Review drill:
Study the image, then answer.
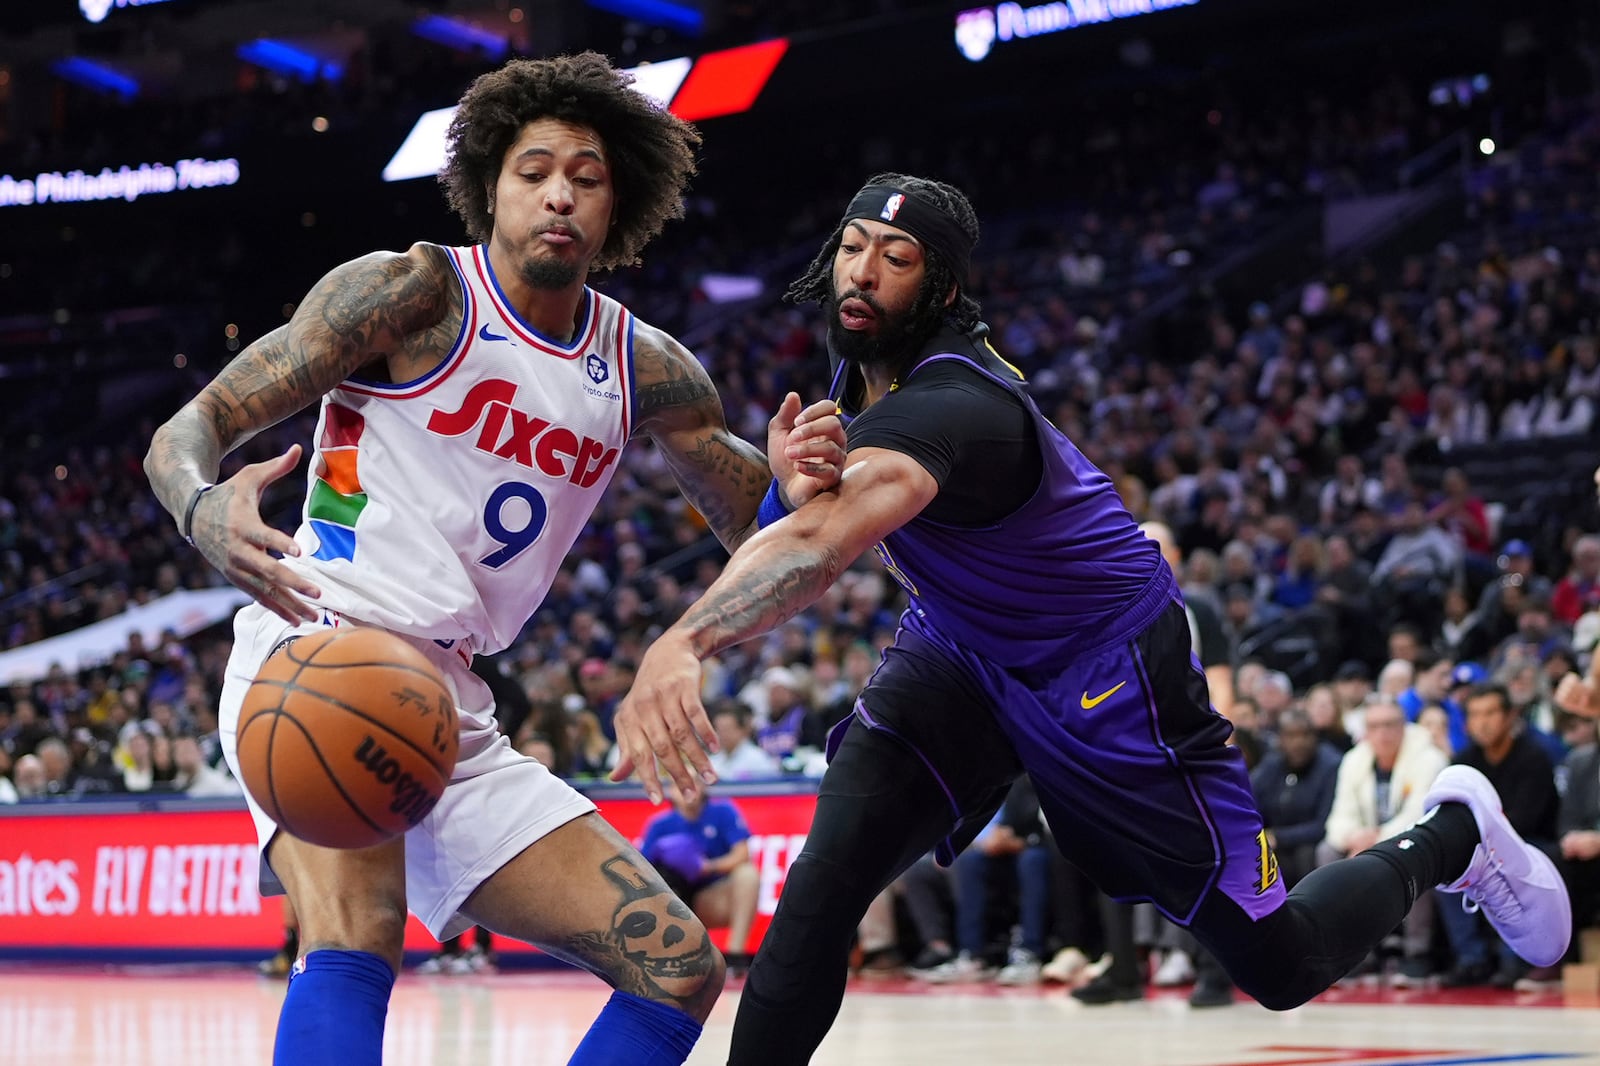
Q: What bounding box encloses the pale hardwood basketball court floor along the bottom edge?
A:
[0,964,1600,1066]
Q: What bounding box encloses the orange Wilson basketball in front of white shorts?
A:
[238,629,459,848]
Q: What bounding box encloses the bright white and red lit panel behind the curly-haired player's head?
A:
[384,37,789,181]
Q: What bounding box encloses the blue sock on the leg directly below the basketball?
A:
[272,949,395,1066]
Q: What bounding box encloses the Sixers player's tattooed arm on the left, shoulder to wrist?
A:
[144,245,461,517]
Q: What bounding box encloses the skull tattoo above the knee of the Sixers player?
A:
[552,853,720,1013]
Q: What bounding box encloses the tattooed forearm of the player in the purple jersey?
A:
[674,539,843,659]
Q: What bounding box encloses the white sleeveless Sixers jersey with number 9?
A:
[285,246,634,653]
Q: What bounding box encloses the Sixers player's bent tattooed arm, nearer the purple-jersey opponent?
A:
[634,328,773,551]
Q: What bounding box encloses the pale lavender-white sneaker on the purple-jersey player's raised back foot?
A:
[1427,765,1573,967]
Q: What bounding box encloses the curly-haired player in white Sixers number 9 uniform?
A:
[146,53,843,1066]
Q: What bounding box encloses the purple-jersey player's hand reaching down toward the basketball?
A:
[611,632,717,804]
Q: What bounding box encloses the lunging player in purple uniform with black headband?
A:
[616,174,1570,1066]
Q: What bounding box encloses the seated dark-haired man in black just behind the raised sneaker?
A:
[1440,685,1560,988]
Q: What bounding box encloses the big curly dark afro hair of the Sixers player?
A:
[438,51,701,271]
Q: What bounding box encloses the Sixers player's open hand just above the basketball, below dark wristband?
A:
[190,445,322,623]
